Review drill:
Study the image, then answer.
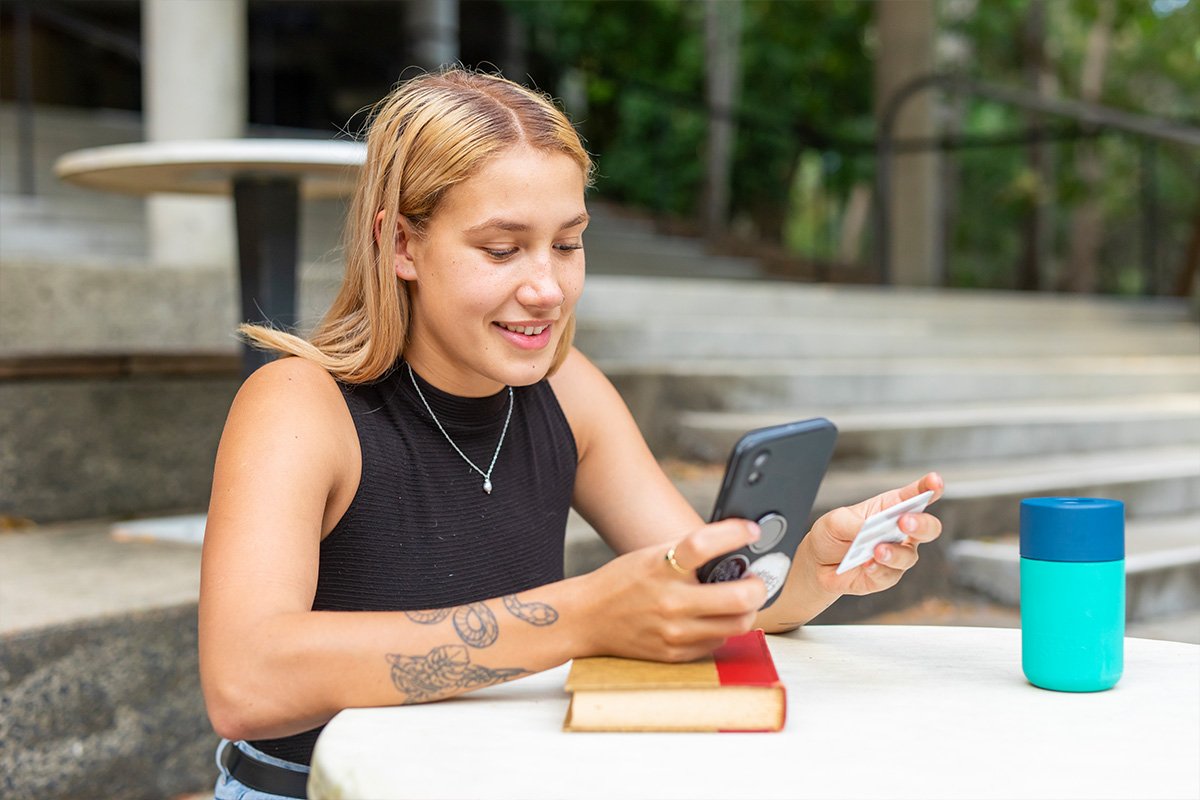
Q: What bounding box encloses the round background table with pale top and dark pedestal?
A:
[54,139,366,374]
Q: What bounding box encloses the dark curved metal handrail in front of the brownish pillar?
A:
[875,73,1200,284]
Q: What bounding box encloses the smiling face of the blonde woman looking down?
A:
[396,146,588,397]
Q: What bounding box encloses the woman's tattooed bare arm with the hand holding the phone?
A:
[200,359,761,739]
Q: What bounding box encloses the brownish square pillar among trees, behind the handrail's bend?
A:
[875,0,942,285]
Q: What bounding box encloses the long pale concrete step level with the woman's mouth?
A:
[576,314,1200,360]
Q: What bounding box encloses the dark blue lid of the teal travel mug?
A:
[1021,498,1124,561]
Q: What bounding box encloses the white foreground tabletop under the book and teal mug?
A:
[308,625,1200,800]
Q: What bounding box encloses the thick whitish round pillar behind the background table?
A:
[142,0,248,269]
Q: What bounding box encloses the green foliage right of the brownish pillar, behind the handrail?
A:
[942,0,1200,293]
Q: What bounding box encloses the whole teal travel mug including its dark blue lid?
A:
[1021,498,1126,692]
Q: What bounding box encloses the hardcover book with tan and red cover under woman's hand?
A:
[563,630,787,732]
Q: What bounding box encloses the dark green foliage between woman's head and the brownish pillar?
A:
[509,0,871,235]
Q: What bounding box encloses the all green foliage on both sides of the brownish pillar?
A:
[506,0,1200,291]
